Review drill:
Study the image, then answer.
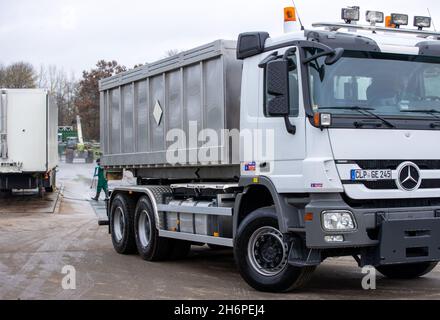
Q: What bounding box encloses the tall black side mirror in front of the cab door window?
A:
[266,60,289,117]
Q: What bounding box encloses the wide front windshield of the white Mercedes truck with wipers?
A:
[309,51,440,120]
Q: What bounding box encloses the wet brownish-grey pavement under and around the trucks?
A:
[0,164,440,300]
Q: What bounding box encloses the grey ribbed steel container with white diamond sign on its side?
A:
[100,40,242,168]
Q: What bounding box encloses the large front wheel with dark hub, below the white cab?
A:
[234,207,316,293]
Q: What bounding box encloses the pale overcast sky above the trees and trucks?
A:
[0,0,440,76]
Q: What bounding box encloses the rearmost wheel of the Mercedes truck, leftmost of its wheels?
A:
[110,194,136,255]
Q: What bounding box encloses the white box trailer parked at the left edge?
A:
[0,89,58,191]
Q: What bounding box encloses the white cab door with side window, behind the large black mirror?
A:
[256,48,306,192]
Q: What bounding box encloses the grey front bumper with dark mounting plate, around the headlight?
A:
[305,194,440,266]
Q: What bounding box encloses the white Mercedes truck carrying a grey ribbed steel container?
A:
[100,8,440,292]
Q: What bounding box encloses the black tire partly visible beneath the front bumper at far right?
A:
[376,262,438,279]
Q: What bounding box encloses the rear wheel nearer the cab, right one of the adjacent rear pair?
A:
[134,197,174,261]
